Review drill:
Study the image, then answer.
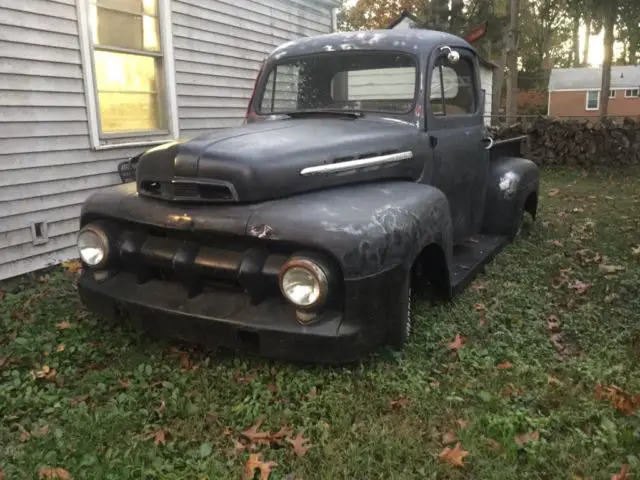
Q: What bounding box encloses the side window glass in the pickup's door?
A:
[429,56,478,116]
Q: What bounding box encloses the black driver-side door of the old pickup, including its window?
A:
[425,46,489,244]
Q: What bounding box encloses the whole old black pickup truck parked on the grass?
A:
[78,30,539,363]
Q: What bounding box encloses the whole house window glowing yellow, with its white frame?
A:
[77,0,177,148]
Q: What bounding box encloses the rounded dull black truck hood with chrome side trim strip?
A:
[137,117,424,203]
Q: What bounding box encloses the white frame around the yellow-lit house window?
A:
[76,0,180,150]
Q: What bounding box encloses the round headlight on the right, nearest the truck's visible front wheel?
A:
[280,259,328,308]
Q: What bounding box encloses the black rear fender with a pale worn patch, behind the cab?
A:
[481,156,540,235]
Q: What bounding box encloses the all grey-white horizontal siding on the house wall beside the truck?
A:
[0,0,332,279]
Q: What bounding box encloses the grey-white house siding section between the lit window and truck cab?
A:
[173,0,332,137]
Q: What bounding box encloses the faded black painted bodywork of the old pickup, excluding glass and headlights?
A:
[79,30,539,362]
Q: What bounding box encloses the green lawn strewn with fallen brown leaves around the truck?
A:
[0,169,640,480]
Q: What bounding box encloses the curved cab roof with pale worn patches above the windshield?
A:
[267,29,475,61]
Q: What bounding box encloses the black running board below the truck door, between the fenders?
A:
[451,234,509,296]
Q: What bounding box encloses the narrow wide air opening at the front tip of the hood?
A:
[140,180,237,202]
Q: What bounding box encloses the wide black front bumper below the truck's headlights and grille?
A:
[78,270,382,363]
